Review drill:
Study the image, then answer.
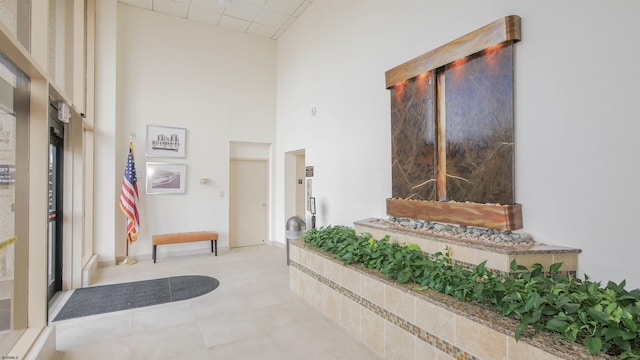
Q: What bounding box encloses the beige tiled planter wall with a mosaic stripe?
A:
[289,241,608,359]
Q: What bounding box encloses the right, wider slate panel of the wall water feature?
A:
[445,45,514,204]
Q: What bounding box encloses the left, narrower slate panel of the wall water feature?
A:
[391,72,436,200]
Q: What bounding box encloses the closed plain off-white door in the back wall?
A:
[229,159,268,247]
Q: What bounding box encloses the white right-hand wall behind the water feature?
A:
[275,0,640,288]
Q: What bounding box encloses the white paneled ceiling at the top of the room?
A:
[118,0,313,40]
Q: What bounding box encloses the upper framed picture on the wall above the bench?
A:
[147,125,187,158]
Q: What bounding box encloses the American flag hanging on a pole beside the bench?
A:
[120,142,140,243]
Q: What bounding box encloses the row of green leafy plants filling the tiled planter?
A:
[303,226,640,359]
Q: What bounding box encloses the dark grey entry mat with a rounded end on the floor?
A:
[53,275,220,321]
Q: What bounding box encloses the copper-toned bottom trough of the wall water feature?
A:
[387,199,522,230]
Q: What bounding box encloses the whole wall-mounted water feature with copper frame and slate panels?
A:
[385,16,522,230]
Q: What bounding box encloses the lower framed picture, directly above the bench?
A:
[146,162,187,194]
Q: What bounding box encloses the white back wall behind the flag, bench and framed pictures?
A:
[96,4,276,261]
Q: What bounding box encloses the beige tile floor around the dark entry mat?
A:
[51,245,379,360]
